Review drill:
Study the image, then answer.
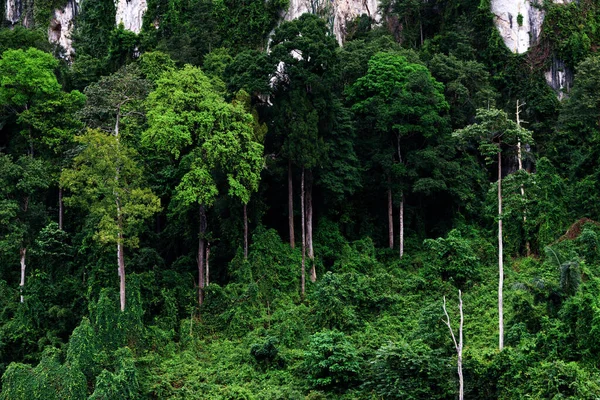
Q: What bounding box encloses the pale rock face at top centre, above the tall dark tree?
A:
[283,0,381,44]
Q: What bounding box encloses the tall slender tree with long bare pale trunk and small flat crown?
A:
[453,109,533,350]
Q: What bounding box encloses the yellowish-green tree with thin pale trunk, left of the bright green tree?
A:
[61,129,160,311]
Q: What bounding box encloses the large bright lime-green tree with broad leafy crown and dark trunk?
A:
[143,65,262,305]
